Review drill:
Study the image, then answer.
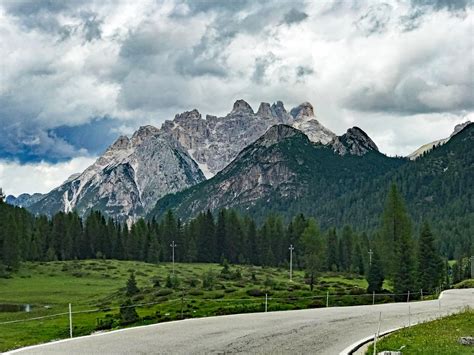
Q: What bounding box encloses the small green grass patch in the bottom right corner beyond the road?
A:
[366,309,474,355]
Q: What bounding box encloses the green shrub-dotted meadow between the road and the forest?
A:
[0,260,390,351]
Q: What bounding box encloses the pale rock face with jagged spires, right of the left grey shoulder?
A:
[161,100,336,178]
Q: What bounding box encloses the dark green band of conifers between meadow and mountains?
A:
[0,185,472,293]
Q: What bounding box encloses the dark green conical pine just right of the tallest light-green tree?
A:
[417,222,443,292]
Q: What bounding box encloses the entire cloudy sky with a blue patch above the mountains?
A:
[0,0,474,194]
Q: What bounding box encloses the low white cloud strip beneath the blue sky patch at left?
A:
[0,157,95,196]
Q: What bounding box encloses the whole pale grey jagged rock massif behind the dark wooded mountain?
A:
[24,100,377,222]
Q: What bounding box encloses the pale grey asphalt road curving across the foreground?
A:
[8,289,474,355]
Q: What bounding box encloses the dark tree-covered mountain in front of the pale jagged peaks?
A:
[148,124,392,219]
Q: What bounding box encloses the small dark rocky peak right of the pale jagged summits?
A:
[332,127,379,156]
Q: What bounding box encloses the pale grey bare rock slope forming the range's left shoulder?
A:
[29,126,204,222]
